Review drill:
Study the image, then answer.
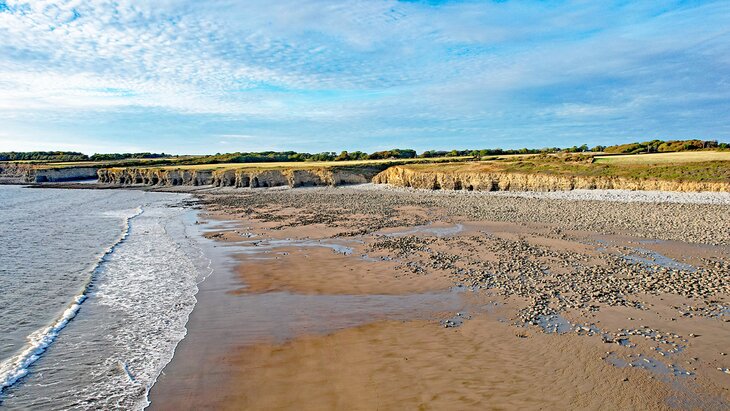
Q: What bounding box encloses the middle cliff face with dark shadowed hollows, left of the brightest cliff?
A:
[98,167,380,188]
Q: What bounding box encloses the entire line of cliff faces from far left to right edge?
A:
[18,162,730,196]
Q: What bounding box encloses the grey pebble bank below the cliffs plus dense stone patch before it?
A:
[196,185,730,350]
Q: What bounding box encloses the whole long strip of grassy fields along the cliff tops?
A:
[9,151,730,182]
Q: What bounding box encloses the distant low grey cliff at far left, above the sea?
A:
[0,163,97,184]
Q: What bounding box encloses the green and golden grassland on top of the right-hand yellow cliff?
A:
[407,152,730,182]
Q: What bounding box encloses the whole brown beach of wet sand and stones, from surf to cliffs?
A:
[150,189,730,410]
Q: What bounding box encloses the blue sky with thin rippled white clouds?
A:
[0,0,730,154]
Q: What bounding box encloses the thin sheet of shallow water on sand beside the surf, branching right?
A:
[150,221,494,409]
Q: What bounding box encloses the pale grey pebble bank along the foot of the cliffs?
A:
[203,185,730,246]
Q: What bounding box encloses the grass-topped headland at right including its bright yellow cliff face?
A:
[373,152,730,191]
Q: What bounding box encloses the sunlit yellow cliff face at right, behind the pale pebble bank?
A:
[373,166,730,192]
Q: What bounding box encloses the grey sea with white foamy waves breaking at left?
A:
[0,186,210,410]
